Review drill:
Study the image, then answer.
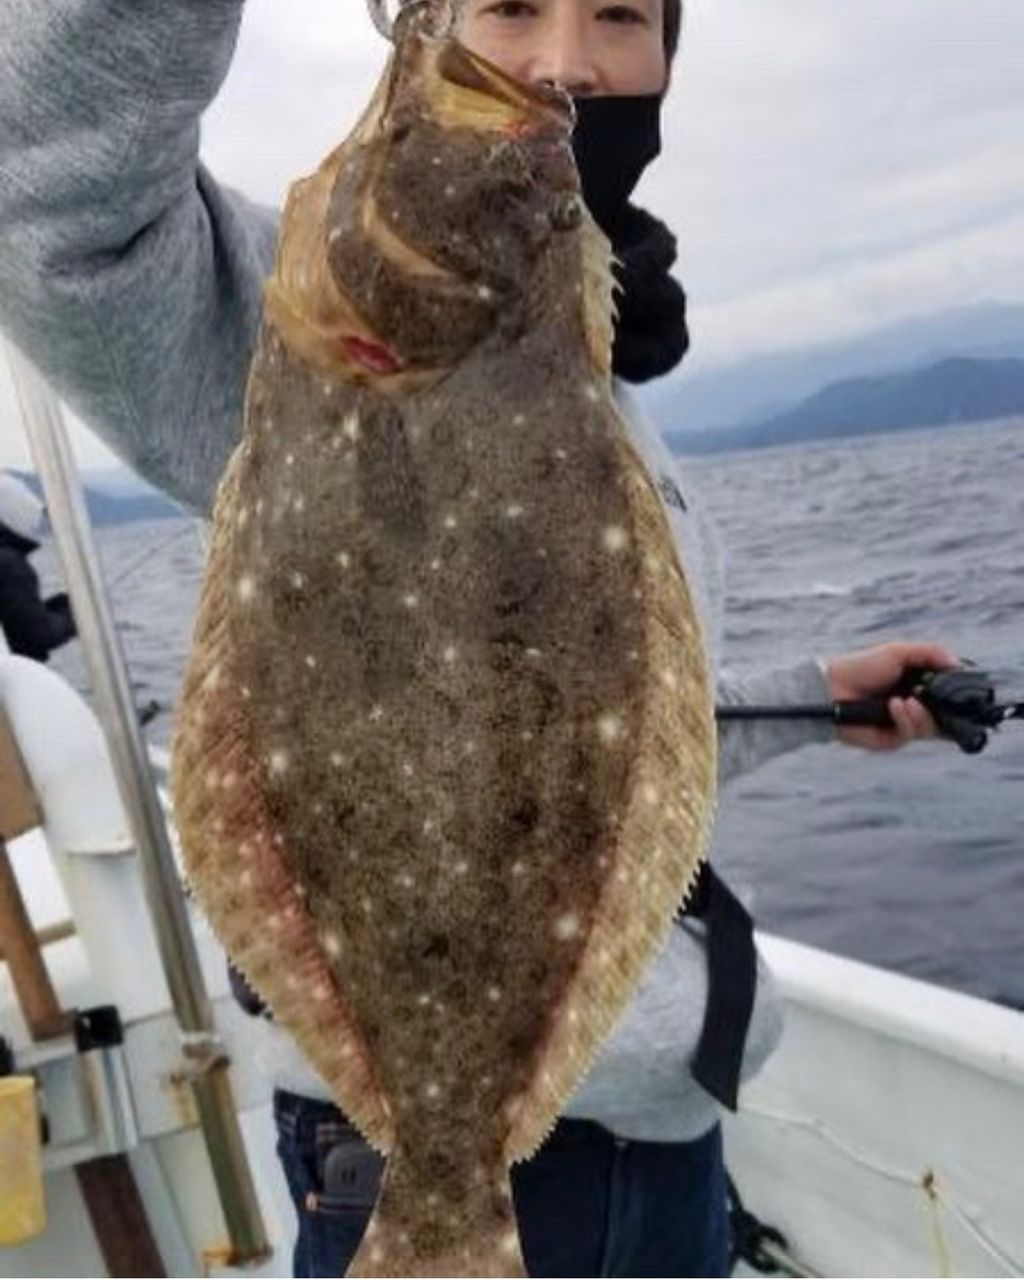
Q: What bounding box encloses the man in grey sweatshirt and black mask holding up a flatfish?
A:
[0,0,956,1276]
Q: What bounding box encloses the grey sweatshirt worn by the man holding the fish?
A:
[0,0,835,1140]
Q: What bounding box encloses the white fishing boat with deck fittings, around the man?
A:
[0,352,1024,1277]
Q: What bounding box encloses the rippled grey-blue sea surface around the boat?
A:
[40,421,1024,1007]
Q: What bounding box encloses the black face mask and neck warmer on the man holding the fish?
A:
[572,93,690,383]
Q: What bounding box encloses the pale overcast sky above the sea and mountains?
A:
[0,0,1024,465]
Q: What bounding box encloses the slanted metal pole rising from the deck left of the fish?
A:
[6,344,268,1261]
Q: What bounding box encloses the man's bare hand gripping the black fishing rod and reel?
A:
[826,641,961,751]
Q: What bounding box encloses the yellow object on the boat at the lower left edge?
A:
[0,1075,46,1245]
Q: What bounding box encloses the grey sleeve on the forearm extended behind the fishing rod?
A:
[717,658,837,787]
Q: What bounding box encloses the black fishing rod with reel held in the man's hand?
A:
[716,664,1024,755]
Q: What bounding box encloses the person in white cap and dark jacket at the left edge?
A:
[0,471,76,662]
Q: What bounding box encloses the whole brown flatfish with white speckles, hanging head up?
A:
[173,9,716,1276]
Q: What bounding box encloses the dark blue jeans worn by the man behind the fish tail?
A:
[274,1091,730,1276]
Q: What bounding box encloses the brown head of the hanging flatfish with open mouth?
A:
[269,5,611,390]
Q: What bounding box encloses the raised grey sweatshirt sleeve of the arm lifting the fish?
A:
[0,0,278,511]
